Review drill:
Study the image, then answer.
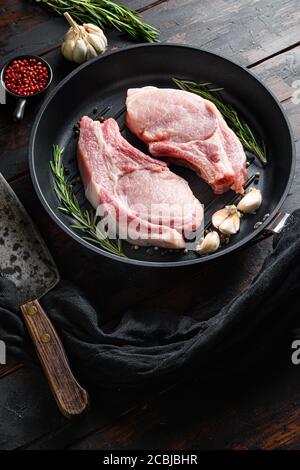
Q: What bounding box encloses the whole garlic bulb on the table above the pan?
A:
[61,13,107,64]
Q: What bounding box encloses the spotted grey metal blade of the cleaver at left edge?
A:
[0,173,60,305]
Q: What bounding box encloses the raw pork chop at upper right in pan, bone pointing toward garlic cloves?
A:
[126,86,247,194]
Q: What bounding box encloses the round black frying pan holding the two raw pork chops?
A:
[29,44,295,267]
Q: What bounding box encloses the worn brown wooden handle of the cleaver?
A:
[21,300,89,418]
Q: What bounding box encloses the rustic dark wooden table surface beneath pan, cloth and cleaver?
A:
[0,0,300,449]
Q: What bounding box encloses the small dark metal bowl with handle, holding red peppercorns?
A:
[0,54,53,122]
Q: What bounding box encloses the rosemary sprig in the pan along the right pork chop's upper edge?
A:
[173,78,267,165]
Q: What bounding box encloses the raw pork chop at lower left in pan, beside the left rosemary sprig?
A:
[78,116,203,248]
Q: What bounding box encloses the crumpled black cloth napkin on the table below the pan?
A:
[0,209,300,388]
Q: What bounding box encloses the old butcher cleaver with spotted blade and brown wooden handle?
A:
[0,173,89,417]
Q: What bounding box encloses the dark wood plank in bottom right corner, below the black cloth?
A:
[70,358,300,450]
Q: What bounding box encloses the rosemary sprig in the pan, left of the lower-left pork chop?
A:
[50,145,125,257]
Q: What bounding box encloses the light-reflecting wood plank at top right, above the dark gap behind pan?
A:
[143,0,300,65]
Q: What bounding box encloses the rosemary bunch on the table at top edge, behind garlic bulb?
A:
[35,0,159,42]
